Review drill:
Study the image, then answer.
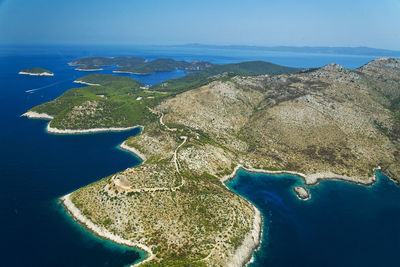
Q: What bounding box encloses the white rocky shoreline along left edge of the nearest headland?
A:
[60,194,154,267]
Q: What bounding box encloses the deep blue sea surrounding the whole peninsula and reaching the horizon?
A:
[0,46,400,266]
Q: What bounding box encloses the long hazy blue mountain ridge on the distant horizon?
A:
[177,43,400,57]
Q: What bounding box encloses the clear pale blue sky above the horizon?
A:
[0,0,400,50]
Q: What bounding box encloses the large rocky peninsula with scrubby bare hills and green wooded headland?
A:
[25,58,400,266]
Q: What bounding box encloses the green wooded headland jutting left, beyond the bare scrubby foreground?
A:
[32,74,166,129]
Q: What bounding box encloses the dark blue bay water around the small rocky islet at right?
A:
[227,170,400,267]
